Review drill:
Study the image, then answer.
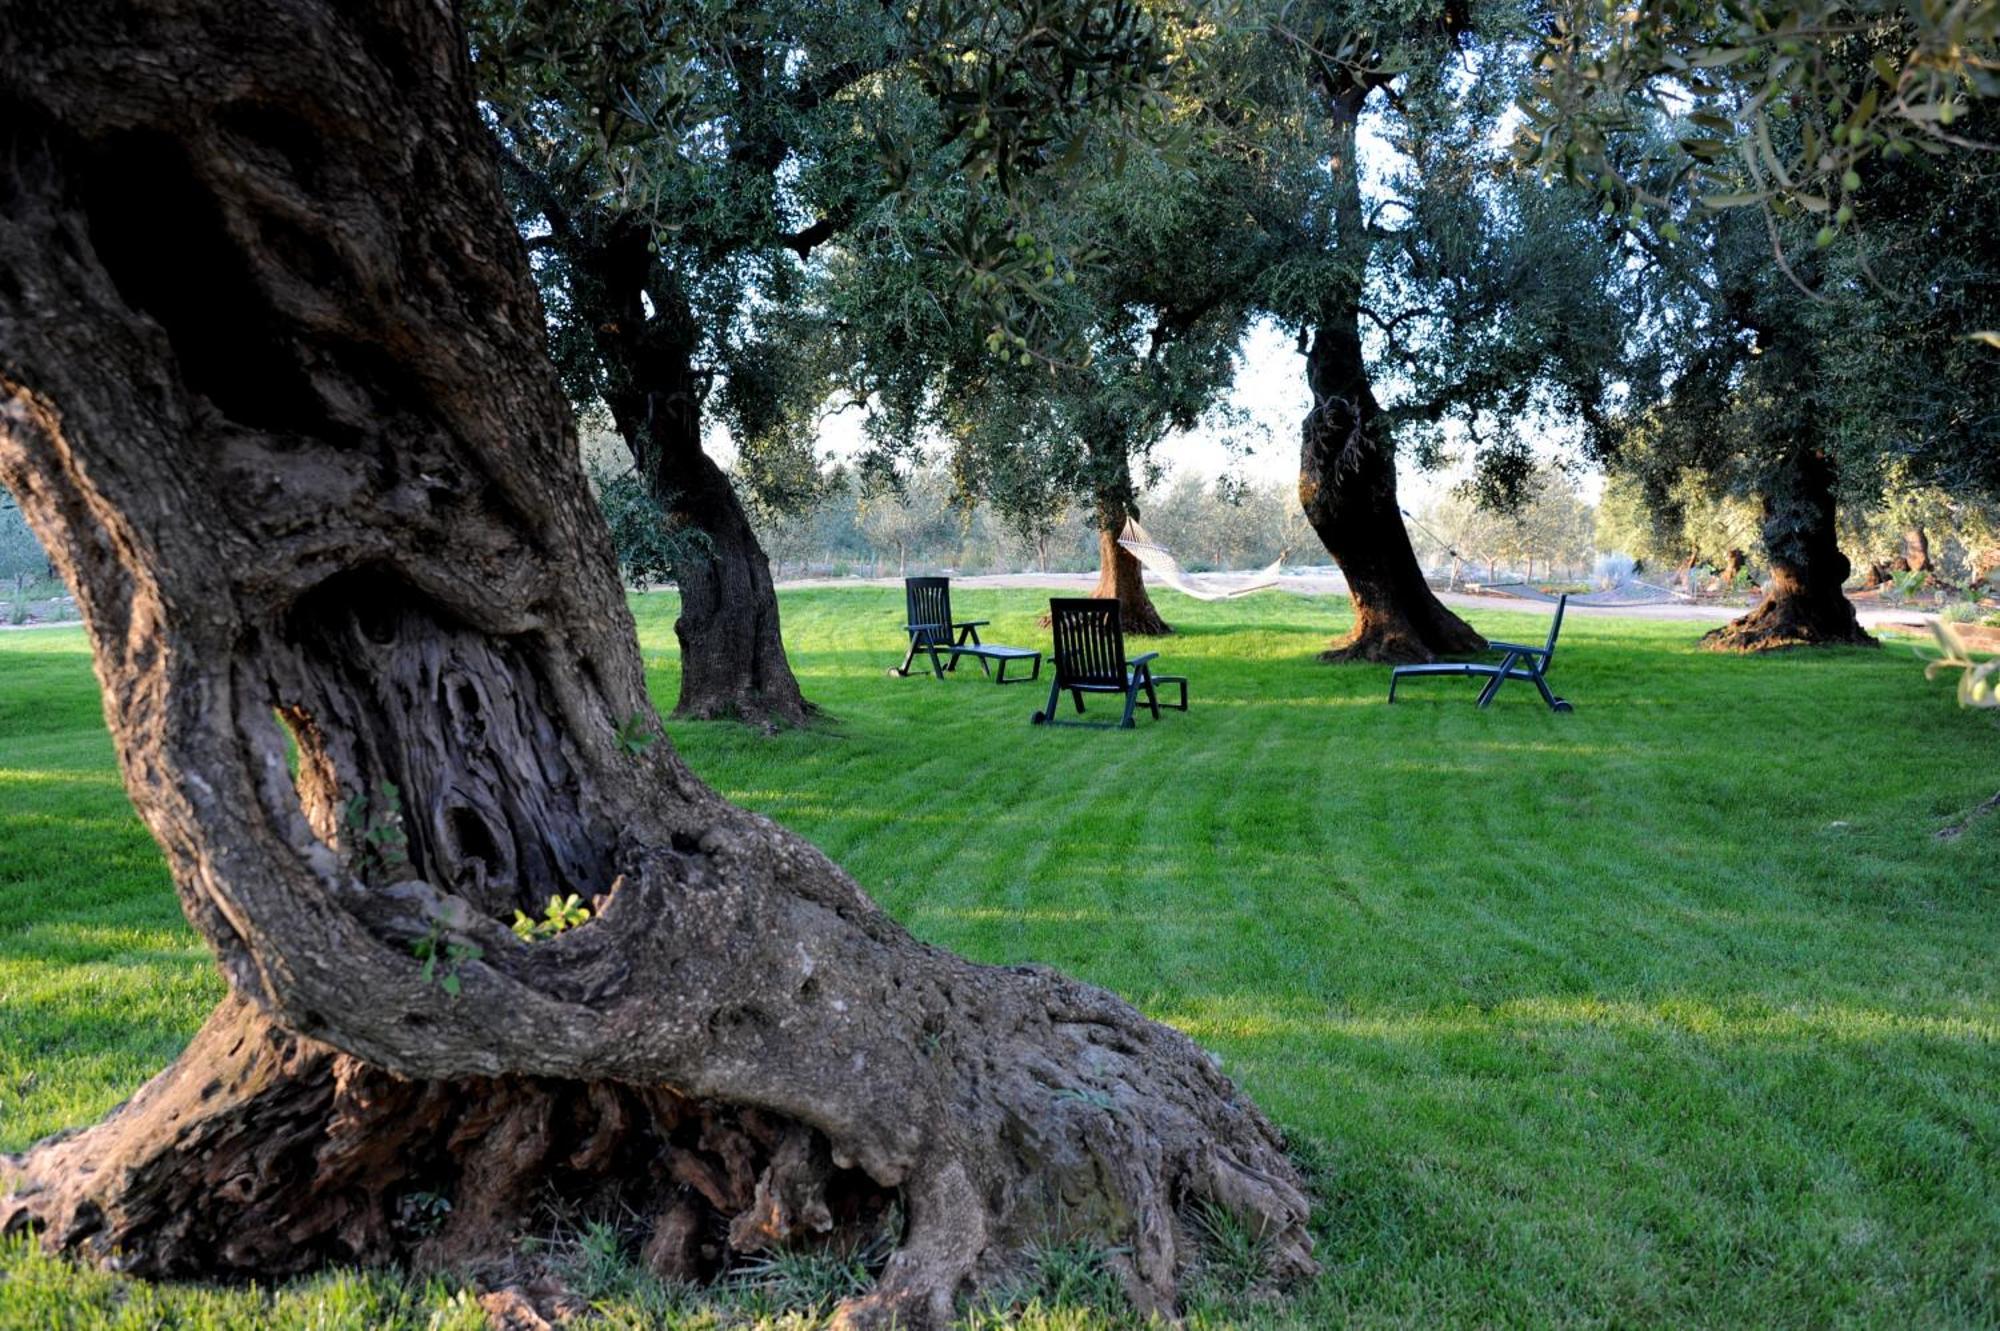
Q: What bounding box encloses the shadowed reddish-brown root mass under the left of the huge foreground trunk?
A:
[0,997,894,1279]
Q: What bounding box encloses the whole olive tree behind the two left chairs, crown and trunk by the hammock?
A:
[822,129,1264,634]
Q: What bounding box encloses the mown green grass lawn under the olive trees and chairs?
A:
[0,590,2000,1327]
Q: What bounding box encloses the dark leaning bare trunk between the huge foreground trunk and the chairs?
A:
[576,230,814,725]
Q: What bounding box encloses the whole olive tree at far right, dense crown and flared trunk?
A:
[1606,69,2000,650]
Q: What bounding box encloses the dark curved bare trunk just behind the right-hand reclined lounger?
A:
[1298,316,1486,664]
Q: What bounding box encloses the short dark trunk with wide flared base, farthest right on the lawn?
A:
[1702,452,1876,652]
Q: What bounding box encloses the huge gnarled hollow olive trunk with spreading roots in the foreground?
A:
[0,0,1312,1327]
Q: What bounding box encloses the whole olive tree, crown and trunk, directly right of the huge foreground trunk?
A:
[468,0,868,723]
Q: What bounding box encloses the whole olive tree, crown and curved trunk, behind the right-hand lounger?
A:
[1260,0,1624,662]
